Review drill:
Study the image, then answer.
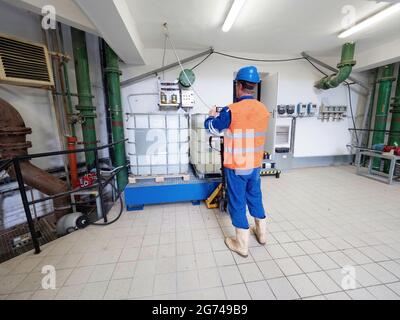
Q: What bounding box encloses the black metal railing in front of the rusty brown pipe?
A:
[0,139,128,254]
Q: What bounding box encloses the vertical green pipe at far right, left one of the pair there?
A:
[372,64,395,171]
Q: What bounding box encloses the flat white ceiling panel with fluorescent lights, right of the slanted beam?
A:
[127,0,400,55]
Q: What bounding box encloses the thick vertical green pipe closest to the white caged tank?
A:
[105,44,128,191]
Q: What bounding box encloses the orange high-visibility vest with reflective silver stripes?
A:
[224,99,270,170]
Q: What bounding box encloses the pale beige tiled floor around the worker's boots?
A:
[0,167,400,300]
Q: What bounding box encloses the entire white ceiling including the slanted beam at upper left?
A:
[0,0,400,67]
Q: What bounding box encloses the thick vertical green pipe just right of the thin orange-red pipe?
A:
[71,28,97,169]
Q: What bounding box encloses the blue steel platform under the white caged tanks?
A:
[125,170,221,211]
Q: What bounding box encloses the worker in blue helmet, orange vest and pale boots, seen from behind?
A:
[204,66,270,258]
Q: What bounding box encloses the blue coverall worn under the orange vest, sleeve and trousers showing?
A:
[204,96,266,229]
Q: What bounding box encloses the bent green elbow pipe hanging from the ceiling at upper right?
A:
[315,42,356,90]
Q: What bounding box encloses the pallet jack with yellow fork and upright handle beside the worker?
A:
[206,137,229,212]
